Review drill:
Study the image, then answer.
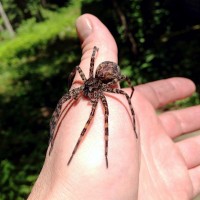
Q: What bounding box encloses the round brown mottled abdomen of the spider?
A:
[95,61,121,83]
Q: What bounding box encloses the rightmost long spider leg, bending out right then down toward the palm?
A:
[103,88,138,139]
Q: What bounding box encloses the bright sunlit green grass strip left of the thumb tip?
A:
[0,10,78,61]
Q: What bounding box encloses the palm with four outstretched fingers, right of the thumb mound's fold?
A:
[134,78,200,199]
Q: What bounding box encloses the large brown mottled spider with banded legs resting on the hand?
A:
[49,46,138,168]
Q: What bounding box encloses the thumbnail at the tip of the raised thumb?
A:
[76,15,92,40]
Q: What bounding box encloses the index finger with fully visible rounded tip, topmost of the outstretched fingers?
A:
[136,78,195,108]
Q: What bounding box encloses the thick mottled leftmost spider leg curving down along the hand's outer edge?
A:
[49,86,84,155]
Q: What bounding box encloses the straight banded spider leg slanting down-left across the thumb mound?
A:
[67,101,98,165]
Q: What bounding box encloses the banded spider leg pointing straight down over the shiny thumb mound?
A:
[100,94,109,168]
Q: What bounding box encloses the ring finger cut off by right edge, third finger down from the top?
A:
[176,136,200,169]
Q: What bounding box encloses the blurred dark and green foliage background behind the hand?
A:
[0,0,200,200]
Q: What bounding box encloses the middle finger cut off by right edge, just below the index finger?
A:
[159,106,200,138]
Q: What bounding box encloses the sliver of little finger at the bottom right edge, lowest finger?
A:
[189,166,200,196]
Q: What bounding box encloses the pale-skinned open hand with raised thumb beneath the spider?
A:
[28,14,200,200]
